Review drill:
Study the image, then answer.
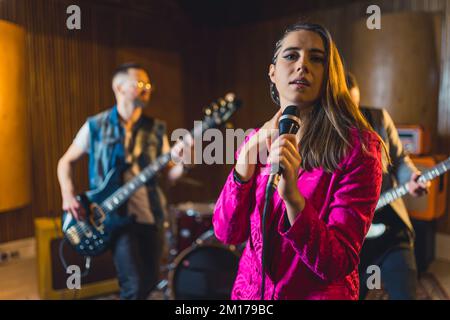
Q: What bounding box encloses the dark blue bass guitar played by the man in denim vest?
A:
[62,93,241,256]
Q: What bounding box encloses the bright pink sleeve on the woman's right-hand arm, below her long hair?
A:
[278,135,382,281]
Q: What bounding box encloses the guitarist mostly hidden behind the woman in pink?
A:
[347,73,430,300]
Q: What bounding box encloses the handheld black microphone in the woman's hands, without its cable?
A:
[267,106,300,189]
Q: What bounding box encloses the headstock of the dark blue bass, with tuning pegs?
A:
[203,93,241,129]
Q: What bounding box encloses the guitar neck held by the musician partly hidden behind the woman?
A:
[375,158,450,210]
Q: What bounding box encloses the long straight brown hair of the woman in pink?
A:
[270,22,389,172]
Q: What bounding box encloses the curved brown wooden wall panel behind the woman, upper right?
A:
[348,13,440,152]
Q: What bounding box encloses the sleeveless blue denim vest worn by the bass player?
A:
[88,106,166,225]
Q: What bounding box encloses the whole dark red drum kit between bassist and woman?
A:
[158,202,244,300]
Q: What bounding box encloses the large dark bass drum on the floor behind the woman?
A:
[169,230,241,300]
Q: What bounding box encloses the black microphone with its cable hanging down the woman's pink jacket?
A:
[261,106,300,300]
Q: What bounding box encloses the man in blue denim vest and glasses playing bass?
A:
[58,63,193,299]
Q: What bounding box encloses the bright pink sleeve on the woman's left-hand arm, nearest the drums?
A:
[213,131,257,244]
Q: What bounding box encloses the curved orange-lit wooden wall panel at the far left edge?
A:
[0,20,31,214]
